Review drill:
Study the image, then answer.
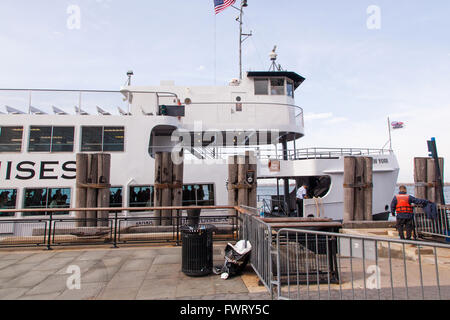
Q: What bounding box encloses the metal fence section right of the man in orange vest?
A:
[414,205,450,242]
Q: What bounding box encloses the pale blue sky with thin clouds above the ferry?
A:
[0,0,450,182]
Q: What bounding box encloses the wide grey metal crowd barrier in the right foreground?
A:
[273,229,450,300]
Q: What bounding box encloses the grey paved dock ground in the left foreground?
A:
[0,245,270,300]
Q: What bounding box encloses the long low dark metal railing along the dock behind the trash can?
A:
[0,207,238,249]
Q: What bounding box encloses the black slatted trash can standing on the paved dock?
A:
[181,226,215,277]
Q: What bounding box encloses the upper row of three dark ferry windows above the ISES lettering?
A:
[0,126,125,152]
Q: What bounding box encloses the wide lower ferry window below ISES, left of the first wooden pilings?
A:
[23,188,70,216]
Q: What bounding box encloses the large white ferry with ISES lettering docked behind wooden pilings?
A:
[0,5,399,234]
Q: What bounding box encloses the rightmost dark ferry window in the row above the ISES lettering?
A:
[81,127,125,152]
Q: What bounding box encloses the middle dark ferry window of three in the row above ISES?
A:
[28,126,75,152]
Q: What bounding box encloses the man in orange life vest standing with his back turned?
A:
[391,186,428,240]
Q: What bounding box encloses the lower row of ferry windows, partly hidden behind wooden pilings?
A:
[0,184,215,217]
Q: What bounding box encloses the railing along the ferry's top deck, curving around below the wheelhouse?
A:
[0,88,304,120]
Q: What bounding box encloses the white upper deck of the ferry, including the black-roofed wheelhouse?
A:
[0,72,304,144]
